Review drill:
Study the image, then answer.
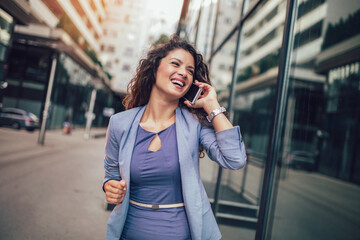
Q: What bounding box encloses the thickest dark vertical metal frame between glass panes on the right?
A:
[255,0,297,240]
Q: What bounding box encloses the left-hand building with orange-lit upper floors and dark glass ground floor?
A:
[0,0,112,128]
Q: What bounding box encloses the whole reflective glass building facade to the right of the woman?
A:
[181,0,360,240]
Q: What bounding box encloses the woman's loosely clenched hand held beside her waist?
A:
[104,180,127,204]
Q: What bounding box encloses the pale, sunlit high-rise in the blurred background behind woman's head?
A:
[101,0,181,94]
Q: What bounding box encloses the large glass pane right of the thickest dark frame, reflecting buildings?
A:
[267,0,360,240]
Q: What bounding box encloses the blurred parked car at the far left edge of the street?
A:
[0,108,39,131]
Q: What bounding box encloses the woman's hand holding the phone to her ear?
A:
[184,80,220,114]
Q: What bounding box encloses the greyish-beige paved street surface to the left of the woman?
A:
[0,128,110,240]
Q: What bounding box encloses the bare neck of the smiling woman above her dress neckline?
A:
[141,94,179,123]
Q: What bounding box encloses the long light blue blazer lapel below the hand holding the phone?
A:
[176,107,202,239]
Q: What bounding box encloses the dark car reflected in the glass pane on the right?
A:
[286,150,316,171]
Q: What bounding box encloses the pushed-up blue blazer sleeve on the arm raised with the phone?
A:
[200,126,247,169]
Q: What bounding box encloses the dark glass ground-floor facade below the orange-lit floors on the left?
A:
[2,34,114,129]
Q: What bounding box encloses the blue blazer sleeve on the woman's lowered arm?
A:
[103,116,121,191]
